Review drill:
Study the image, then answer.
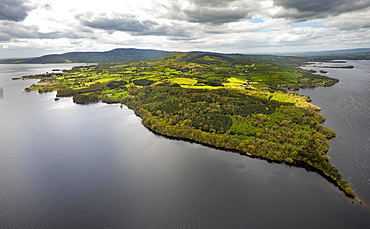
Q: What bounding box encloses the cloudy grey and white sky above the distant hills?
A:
[0,0,370,59]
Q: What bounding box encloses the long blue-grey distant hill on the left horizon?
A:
[0,48,171,64]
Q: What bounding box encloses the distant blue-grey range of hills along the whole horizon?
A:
[0,48,370,64]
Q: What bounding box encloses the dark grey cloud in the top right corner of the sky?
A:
[274,0,370,20]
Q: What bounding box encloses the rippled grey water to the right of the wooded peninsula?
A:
[300,60,370,203]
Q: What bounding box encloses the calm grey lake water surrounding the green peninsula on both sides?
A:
[0,61,370,228]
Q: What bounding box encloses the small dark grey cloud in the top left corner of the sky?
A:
[0,0,33,21]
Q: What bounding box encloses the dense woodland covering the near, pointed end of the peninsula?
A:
[123,87,354,197]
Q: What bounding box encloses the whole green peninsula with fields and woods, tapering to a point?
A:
[24,52,360,201]
